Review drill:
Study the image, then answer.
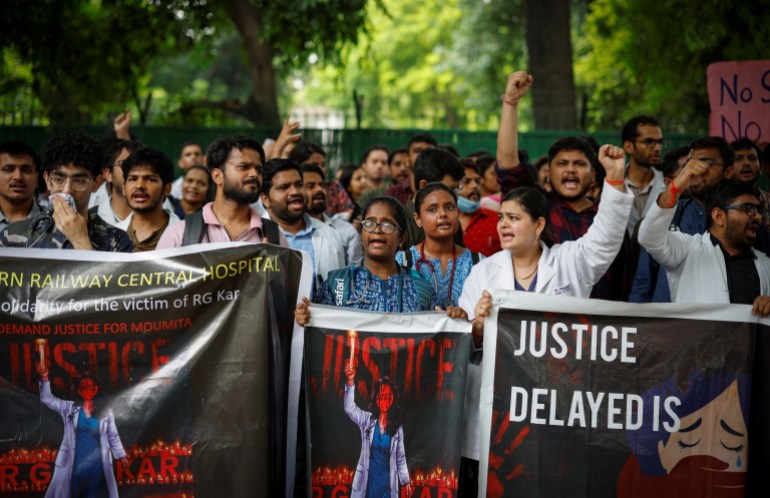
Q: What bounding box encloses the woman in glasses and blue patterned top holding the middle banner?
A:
[295,196,466,326]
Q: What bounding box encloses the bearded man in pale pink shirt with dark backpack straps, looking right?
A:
[157,136,288,249]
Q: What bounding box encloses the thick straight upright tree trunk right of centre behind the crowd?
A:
[527,0,577,130]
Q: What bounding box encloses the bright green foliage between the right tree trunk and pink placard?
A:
[576,0,770,131]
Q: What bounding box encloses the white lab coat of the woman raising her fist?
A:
[459,183,634,460]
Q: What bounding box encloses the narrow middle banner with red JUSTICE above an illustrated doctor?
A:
[305,305,471,498]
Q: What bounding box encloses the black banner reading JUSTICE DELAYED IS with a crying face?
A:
[480,291,767,498]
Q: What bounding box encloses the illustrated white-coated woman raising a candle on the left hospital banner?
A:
[37,363,128,498]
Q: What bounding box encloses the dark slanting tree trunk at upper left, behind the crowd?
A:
[225,0,281,128]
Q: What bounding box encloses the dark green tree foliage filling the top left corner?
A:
[0,0,205,124]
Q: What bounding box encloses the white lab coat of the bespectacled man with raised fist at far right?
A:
[639,204,770,303]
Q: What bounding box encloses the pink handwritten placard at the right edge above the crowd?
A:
[707,60,770,142]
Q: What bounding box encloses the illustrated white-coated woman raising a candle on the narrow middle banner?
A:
[344,363,412,498]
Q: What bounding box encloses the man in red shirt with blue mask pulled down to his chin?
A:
[456,159,500,256]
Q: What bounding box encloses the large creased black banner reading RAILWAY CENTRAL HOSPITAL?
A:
[0,244,309,498]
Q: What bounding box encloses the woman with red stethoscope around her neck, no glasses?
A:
[396,182,481,309]
